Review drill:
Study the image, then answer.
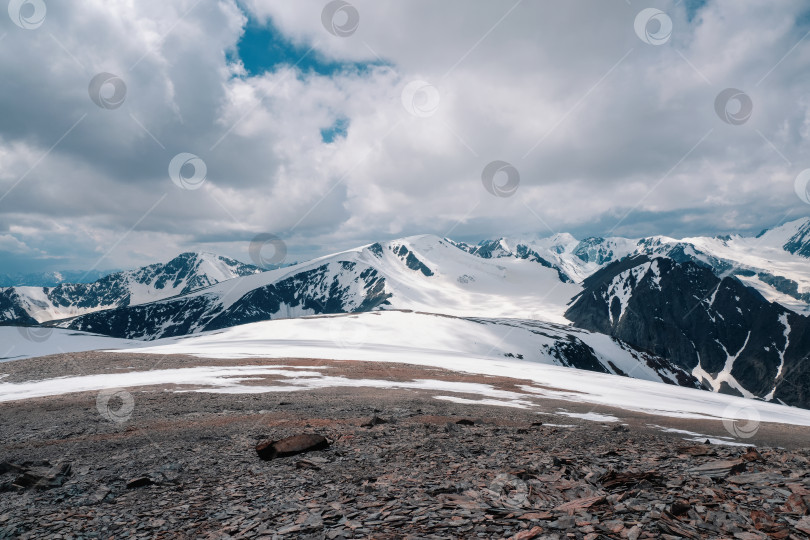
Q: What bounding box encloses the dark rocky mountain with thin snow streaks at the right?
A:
[566,255,810,407]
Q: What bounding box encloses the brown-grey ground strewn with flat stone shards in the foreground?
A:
[0,353,810,540]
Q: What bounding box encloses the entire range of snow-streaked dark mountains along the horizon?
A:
[0,219,810,407]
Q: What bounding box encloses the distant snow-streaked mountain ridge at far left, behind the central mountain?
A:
[0,253,261,324]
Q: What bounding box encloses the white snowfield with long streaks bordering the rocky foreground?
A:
[0,312,810,426]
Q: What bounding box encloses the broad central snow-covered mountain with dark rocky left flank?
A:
[59,235,580,339]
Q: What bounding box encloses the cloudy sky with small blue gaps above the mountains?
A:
[0,0,810,273]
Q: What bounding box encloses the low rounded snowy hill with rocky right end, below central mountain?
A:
[145,311,699,388]
